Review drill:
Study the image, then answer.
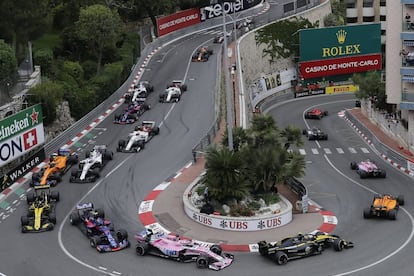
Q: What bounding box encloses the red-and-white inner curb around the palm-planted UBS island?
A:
[138,162,338,252]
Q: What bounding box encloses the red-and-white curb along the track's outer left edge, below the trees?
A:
[0,47,161,202]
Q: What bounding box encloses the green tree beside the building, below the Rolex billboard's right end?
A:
[352,71,388,110]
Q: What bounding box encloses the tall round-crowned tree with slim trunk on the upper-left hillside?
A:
[76,5,122,75]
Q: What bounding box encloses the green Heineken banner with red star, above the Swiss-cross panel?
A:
[0,104,43,142]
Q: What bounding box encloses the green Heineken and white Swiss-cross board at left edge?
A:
[0,104,45,166]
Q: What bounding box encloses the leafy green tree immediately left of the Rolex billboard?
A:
[256,17,319,62]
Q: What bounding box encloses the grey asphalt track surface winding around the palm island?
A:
[0,2,413,276]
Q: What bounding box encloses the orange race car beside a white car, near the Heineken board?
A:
[30,149,78,187]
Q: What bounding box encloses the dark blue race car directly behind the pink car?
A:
[69,203,130,253]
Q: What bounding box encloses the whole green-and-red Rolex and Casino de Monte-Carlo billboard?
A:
[299,23,382,79]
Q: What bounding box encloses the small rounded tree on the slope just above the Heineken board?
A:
[28,81,64,126]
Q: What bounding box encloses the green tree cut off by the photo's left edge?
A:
[0,40,17,102]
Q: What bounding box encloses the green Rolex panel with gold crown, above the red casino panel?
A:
[299,23,381,62]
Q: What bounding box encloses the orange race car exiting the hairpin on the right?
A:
[364,194,404,220]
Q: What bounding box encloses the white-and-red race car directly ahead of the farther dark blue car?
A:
[117,121,160,152]
